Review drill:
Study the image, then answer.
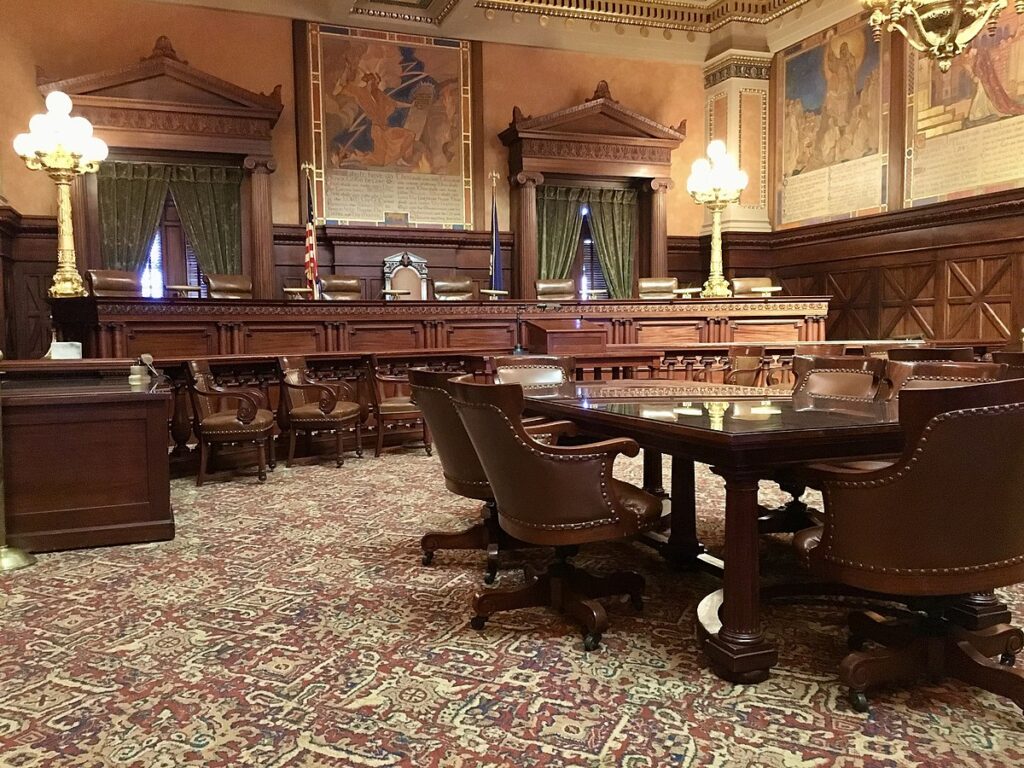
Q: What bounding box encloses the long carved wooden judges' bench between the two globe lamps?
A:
[52,296,828,357]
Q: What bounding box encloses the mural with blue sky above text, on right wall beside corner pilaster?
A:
[775,14,890,226]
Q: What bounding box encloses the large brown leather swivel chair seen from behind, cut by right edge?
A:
[794,380,1024,712]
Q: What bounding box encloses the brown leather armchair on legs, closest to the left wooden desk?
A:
[185,360,274,485]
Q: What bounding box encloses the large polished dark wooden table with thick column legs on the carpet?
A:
[526,391,903,683]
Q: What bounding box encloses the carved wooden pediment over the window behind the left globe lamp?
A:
[39,37,282,155]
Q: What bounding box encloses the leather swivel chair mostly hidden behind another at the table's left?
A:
[409,369,575,584]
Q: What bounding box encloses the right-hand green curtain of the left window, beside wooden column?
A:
[170,165,242,274]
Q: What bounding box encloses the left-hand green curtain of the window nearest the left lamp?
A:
[96,162,171,272]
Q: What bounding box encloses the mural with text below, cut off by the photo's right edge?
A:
[905,12,1024,206]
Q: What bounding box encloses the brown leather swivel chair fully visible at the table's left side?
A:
[451,380,662,650]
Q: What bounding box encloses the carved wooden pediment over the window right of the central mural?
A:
[500,80,686,177]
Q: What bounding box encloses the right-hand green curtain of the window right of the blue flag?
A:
[578,189,637,299]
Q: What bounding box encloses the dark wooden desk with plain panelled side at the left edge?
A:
[0,376,174,552]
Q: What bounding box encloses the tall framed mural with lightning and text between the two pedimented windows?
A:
[300,24,473,229]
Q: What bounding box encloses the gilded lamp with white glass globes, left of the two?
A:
[14,91,108,299]
